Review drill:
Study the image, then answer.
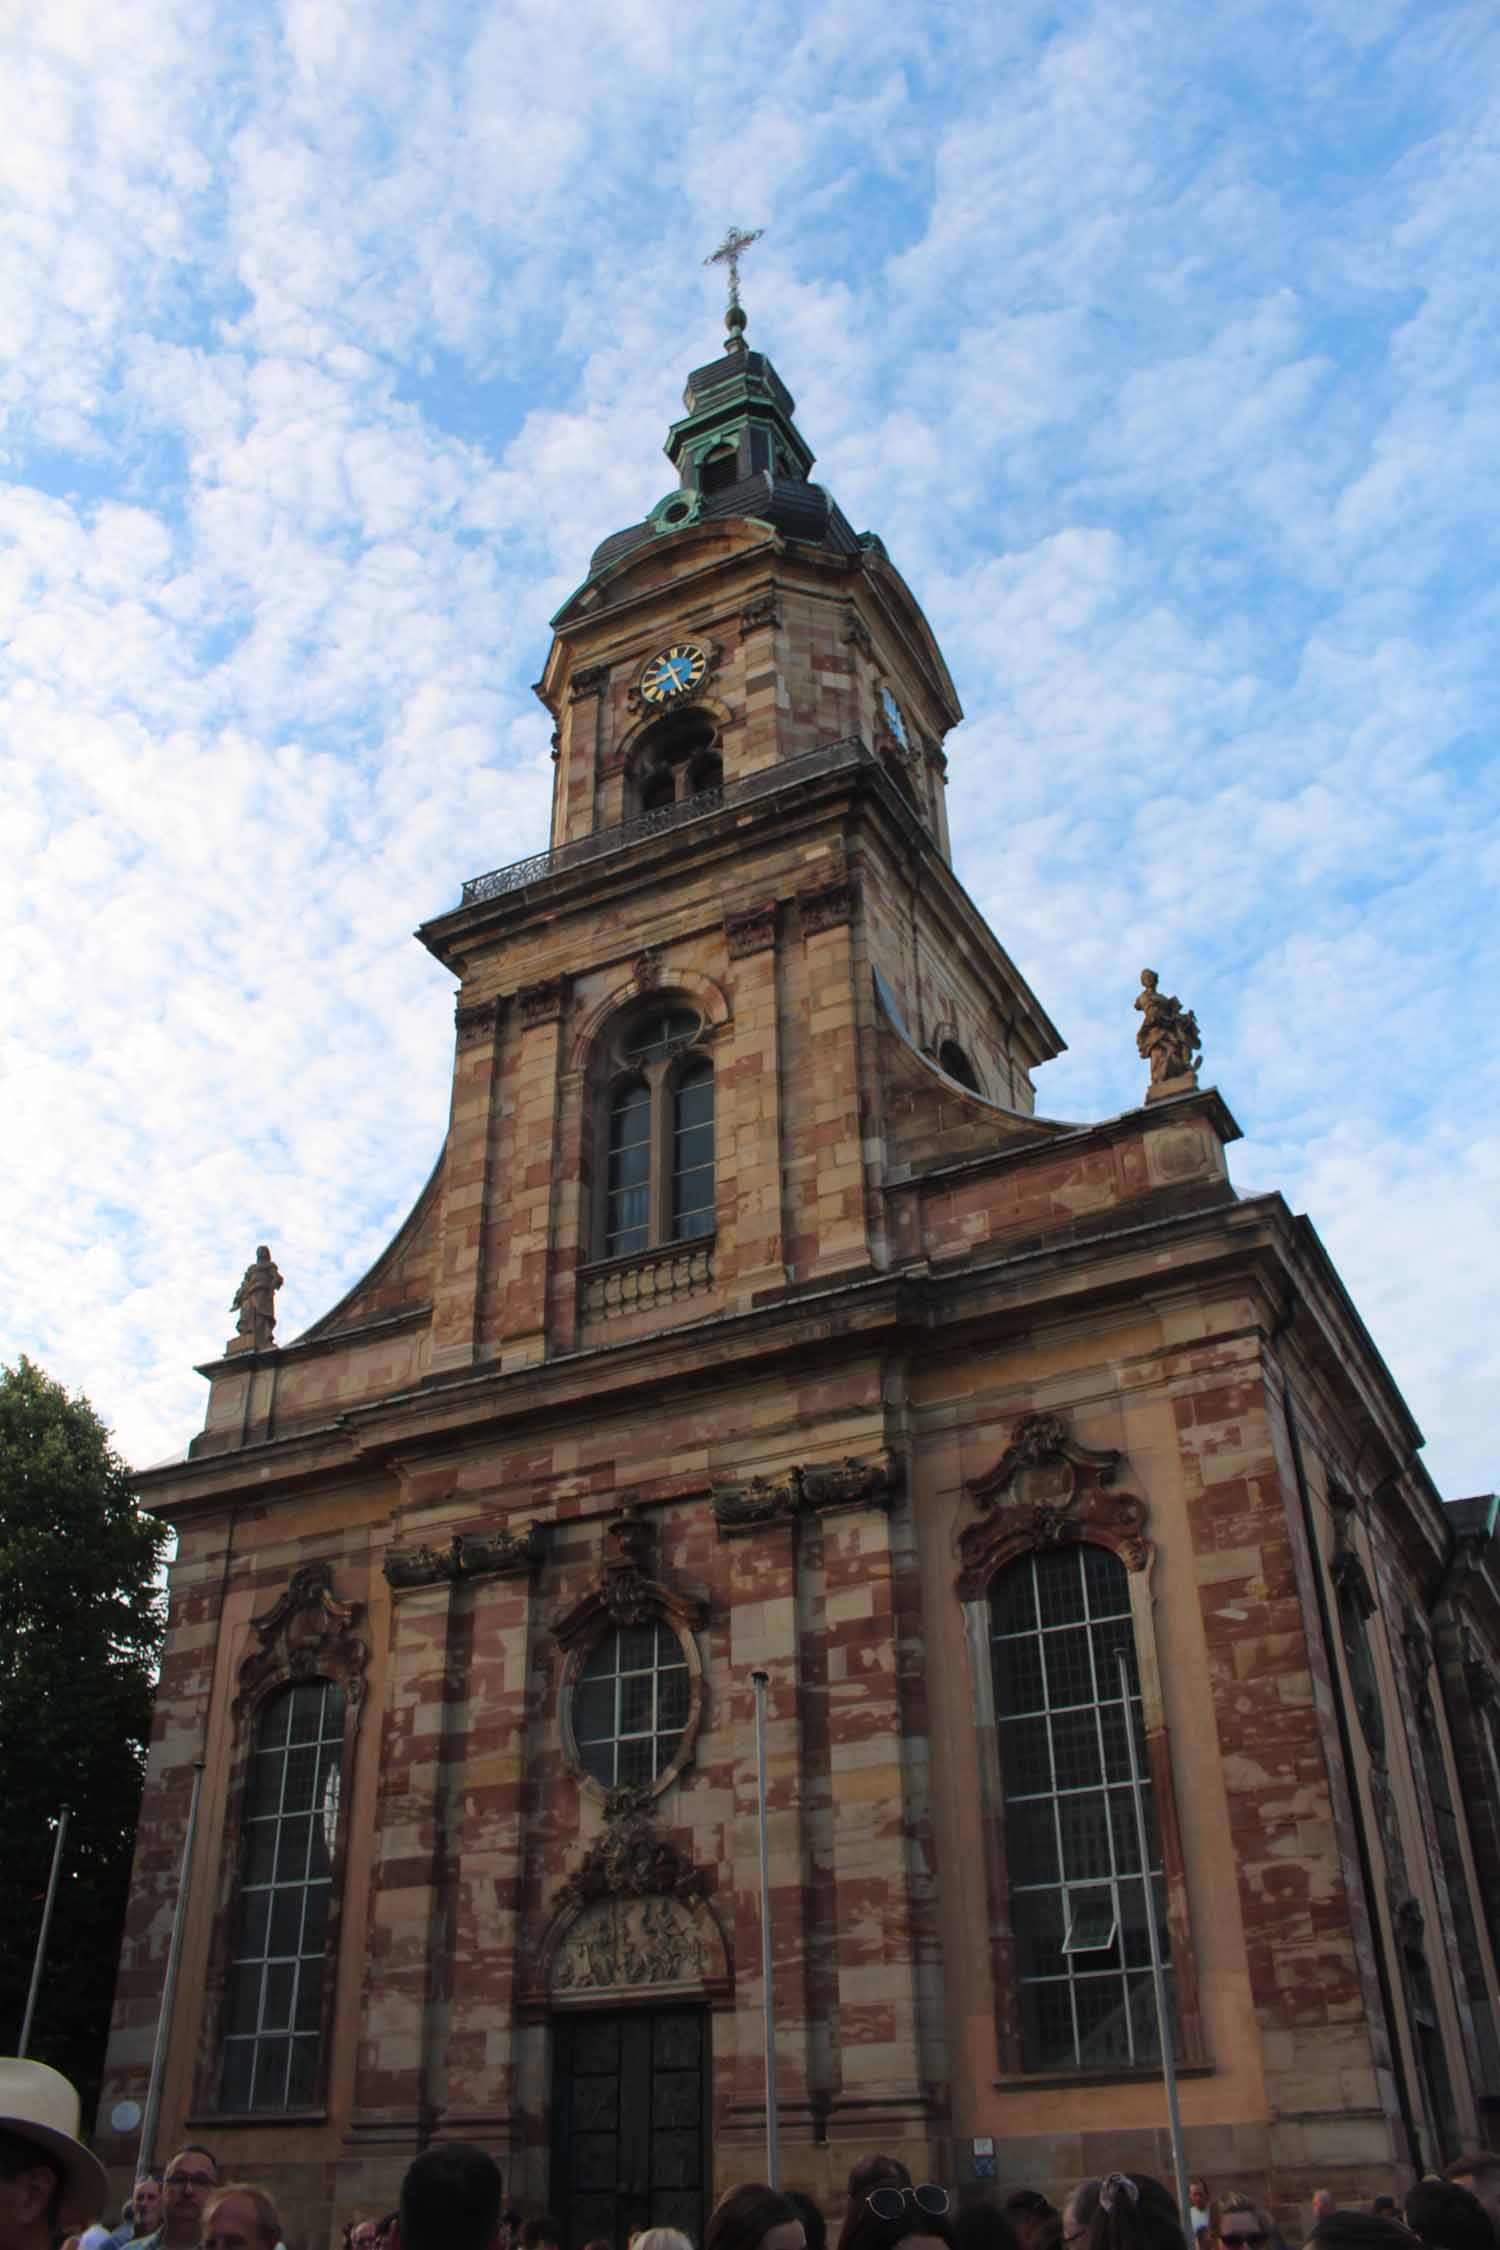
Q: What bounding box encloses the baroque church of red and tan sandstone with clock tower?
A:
[99,290,1500,2250]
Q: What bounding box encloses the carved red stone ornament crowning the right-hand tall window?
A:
[958,1413,1151,1602]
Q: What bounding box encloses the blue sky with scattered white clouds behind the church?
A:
[0,0,1500,1494]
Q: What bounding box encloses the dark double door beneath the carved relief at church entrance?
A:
[551,2007,711,2250]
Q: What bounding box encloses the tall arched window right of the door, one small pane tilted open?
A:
[990,1546,1169,2070]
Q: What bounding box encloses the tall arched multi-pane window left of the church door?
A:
[218,1681,344,2111]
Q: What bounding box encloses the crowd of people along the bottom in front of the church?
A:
[0,2059,1500,2250]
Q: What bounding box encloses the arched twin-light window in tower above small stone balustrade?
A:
[598,1001,715,1258]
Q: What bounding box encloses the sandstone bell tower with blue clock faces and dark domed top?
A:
[413,299,1061,1366]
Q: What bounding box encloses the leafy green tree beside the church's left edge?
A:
[0,1359,166,2117]
